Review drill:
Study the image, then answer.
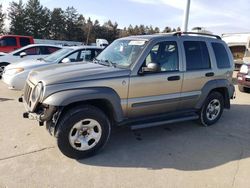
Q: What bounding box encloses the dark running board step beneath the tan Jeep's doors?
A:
[130,115,199,130]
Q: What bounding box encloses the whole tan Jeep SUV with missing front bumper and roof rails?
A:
[19,32,234,159]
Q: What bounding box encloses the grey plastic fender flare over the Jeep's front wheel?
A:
[42,87,124,122]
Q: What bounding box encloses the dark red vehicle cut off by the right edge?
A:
[237,62,250,92]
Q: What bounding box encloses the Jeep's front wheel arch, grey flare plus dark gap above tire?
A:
[43,87,124,122]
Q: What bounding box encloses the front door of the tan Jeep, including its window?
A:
[128,41,183,117]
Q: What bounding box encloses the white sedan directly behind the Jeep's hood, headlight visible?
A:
[2,46,103,90]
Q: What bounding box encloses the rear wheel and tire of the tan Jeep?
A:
[199,92,224,127]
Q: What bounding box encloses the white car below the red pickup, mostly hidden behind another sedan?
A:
[0,44,62,76]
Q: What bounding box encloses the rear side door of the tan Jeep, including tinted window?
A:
[181,38,215,110]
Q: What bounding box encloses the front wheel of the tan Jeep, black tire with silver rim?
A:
[56,105,111,159]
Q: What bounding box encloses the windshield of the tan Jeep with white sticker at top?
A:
[96,40,147,67]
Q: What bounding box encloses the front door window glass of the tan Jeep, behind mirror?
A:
[145,41,179,72]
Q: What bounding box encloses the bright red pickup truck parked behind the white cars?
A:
[0,35,34,53]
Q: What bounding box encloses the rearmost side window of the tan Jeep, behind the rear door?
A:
[212,42,230,68]
